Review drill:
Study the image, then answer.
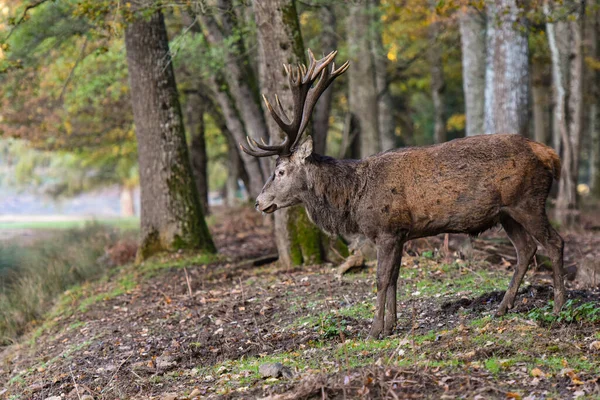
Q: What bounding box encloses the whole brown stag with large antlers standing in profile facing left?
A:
[240,50,566,338]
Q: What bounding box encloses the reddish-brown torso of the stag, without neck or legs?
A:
[358,135,552,241]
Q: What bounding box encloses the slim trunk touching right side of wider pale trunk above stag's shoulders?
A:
[372,0,398,151]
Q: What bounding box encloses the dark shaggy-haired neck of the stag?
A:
[303,154,361,234]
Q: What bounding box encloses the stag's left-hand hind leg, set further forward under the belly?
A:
[496,216,537,317]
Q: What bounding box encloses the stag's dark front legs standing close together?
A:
[369,238,402,339]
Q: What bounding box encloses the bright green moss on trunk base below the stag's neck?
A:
[288,206,324,265]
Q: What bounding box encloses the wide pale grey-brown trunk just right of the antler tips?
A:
[347,0,381,158]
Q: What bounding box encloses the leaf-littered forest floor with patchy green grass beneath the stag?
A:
[0,210,600,400]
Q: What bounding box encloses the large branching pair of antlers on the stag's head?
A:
[240,49,350,157]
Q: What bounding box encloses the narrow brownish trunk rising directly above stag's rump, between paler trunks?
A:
[531,58,552,144]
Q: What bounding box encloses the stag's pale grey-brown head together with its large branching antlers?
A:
[240,50,349,213]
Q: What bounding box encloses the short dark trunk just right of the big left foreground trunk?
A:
[186,93,210,216]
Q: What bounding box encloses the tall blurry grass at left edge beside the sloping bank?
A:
[0,224,135,344]
